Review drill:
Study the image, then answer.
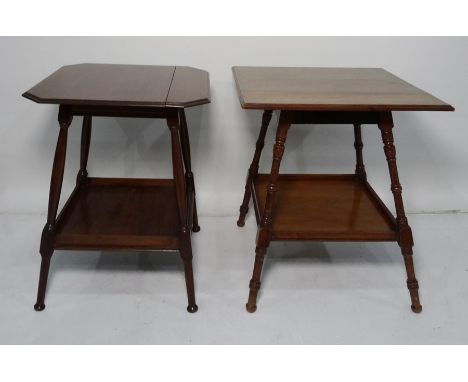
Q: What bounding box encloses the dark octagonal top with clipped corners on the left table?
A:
[23,64,210,107]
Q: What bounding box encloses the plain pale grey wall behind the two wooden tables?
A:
[0,37,468,219]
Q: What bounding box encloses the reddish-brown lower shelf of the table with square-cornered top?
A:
[252,174,397,241]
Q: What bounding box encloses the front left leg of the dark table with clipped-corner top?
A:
[34,106,73,311]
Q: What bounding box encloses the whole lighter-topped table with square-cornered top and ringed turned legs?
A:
[233,67,454,313]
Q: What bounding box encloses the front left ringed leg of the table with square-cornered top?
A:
[246,111,292,313]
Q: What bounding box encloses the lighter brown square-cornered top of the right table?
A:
[232,66,454,111]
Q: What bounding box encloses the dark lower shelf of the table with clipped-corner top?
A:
[55,178,179,250]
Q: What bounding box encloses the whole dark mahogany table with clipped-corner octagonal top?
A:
[23,64,210,313]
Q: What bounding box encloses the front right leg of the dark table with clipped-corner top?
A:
[167,113,198,313]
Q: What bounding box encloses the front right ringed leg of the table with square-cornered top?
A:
[379,112,422,313]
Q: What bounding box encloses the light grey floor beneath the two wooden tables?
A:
[0,214,468,344]
